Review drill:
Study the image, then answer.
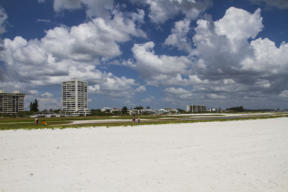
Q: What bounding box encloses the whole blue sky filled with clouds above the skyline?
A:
[0,0,288,109]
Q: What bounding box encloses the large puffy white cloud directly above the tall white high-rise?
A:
[42,13,145,60]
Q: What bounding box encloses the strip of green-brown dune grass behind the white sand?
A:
[0,113,288,130]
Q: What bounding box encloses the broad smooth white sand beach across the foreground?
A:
[0,118,288,192]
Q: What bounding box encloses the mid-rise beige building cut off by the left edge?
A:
[0,91,25,114]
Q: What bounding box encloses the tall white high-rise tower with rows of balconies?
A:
[62,80,88,115]
